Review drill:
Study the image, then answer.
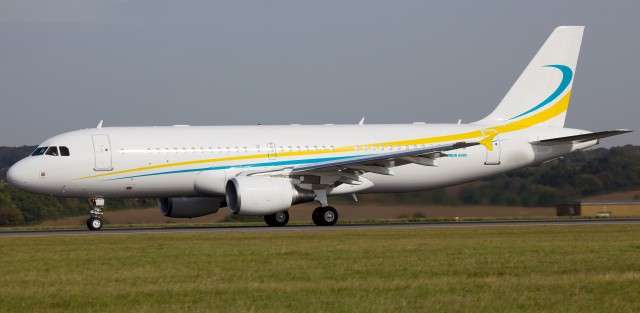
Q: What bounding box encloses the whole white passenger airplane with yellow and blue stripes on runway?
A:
[7,26,630,230]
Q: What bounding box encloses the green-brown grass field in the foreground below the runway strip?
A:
[0,225,640,313]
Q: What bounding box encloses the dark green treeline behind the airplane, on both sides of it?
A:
[0,145,640,225]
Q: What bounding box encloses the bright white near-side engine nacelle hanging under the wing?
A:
[226,176,315,215]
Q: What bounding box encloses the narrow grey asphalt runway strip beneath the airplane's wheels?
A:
[0,218,640,237]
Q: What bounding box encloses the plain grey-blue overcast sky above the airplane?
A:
[0,0,640,145]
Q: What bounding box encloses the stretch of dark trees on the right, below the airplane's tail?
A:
[344,145,640,207]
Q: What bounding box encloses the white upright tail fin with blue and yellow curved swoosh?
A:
[476,26,584,127]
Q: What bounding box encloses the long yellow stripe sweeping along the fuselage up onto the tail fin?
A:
[78,91,571,179]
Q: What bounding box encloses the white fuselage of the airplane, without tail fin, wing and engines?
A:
[8,124,597,197]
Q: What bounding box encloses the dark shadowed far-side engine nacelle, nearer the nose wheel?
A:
[159,197,225,218]
